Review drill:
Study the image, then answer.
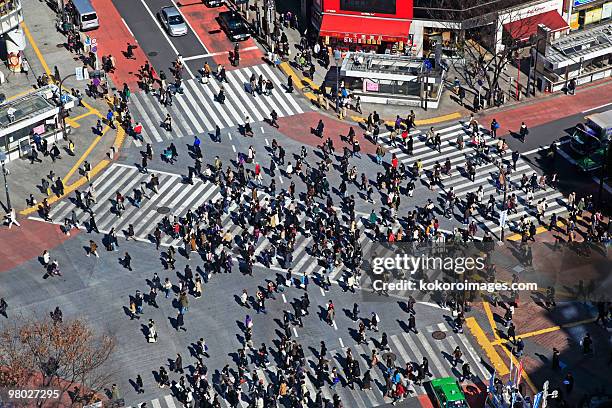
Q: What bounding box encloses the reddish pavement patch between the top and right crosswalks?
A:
[278,112,378,155]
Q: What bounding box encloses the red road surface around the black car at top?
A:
[177,0,263,69]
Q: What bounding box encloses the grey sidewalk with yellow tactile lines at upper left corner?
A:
[1,0,124,217]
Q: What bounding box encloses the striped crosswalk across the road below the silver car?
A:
[130,64,303,146]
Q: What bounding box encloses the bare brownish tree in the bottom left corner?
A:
[0,317,116,407]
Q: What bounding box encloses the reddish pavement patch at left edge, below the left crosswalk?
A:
[0,219,79,272]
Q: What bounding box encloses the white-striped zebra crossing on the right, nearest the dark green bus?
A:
[379,122,567,234]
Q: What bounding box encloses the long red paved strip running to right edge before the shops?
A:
[479,80,612,134]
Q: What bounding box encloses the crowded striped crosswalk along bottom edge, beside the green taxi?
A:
[128,323,491,408]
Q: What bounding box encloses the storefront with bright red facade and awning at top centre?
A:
[312,0,413,54]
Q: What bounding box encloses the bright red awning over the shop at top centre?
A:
[319,14,410,44]
